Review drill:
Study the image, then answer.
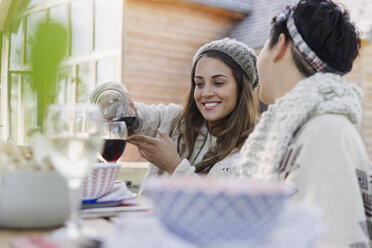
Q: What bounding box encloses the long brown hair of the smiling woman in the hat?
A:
[177,51,256,173]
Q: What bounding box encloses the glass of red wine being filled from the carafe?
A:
[101,120,128,162]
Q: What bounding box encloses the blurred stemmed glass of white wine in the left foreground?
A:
[44,104,103,239]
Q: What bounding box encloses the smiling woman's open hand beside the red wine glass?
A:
[127,129,182,174]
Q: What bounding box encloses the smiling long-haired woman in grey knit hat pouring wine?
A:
[91,38,258,195]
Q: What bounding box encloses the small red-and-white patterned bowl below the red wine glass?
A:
[82,163,121,200]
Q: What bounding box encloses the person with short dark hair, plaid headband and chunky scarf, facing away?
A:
[237,0,372,247]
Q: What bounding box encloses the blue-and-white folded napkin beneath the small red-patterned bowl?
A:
[82,182,137,209]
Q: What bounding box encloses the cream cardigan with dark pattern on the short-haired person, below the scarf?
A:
[279,114,372,247]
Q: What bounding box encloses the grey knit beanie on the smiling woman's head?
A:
[193,38,258,88]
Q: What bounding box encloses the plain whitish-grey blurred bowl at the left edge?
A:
[0,171,70,228]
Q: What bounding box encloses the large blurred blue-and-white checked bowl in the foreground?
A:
[148,177,293,245]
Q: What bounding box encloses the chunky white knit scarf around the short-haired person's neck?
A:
[237,72,362,180]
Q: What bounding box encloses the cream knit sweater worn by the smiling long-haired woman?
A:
[134,102,239,194]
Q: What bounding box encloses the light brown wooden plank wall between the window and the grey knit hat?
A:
[121,0,243,161]
